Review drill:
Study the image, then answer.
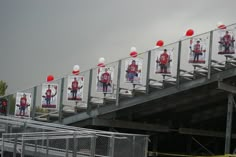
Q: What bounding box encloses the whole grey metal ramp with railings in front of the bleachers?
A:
[0,116,148,157]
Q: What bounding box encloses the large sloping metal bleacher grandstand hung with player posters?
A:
[1,24,236,156]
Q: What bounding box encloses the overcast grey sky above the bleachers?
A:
[0,0,236,93]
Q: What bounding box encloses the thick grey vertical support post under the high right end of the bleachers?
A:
[225,93,234,154]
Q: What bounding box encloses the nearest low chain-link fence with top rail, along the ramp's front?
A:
[1,131,147,157]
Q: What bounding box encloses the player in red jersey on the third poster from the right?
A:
[156,49,170,73]
